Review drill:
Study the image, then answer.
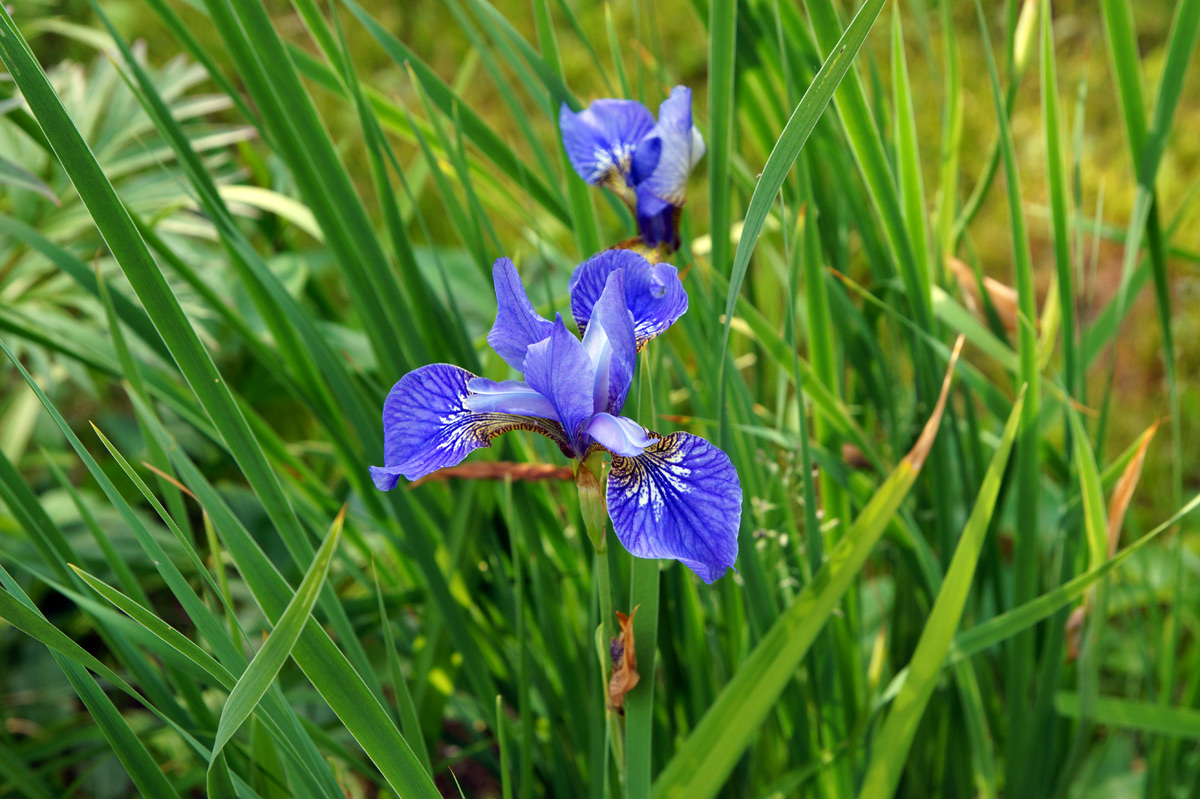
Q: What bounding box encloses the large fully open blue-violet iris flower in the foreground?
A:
[371,250,742,583]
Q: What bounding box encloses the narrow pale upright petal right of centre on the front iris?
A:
[583,269,637,414]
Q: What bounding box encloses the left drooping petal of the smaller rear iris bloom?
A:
[558,100,654,185]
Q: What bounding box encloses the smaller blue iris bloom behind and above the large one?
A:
[558,86,704,252]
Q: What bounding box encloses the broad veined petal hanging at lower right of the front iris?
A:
[607,433,742,583]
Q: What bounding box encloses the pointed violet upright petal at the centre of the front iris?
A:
[523,317,595,456]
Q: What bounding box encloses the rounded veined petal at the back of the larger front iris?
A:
[569,250,688,349]
